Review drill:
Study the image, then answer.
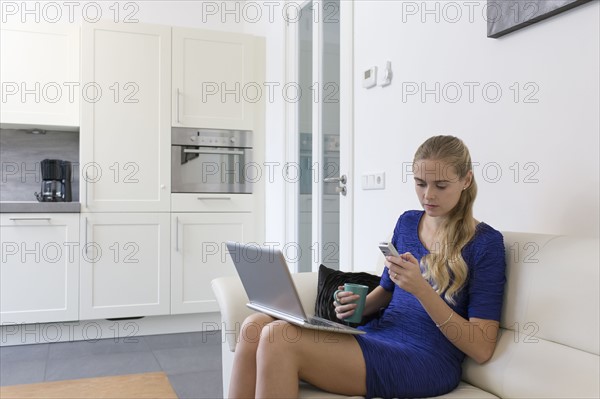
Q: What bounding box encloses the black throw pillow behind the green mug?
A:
[315,265,381,326]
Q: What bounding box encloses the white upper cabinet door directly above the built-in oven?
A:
[172,28,258,130]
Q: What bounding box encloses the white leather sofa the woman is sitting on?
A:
[212,232,600,398]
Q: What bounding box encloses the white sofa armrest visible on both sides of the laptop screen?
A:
[211,272,319,352]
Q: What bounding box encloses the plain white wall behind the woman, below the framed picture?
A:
[354,1,600,270]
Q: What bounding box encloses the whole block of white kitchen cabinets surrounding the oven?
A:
[0,21,266,323]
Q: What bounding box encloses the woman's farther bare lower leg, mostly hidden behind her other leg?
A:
[230,313,275,398]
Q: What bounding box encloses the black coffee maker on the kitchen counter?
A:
[35,159,73,202]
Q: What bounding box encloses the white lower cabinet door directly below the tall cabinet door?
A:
[80,213,170,319]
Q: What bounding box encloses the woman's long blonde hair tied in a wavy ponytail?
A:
[413,136,477,304]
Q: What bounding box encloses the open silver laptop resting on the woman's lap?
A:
[227,241,365,334]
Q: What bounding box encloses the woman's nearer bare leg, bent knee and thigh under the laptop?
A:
[253,320,366,398]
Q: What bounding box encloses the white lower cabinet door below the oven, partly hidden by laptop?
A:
[171,213,255,314]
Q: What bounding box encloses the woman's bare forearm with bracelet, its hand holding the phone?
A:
[386,253,499,364]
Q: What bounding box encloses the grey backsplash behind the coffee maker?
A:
[0,129,80,202]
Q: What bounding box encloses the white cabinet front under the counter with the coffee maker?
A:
[0,213,80,324]
